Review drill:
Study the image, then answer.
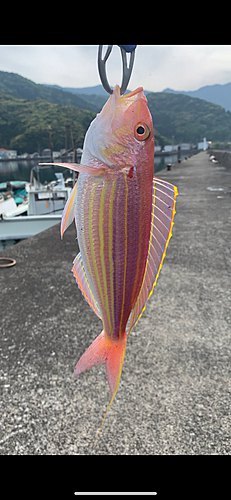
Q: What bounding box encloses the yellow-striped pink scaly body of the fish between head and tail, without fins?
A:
[76,164,152,339]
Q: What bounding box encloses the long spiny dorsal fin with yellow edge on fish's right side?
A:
[129,177,178,335]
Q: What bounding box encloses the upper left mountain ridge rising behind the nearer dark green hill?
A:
[0,71,97,112]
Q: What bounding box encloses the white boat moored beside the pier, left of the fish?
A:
[0,169,72,240]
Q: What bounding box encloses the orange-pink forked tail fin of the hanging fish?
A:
[74,330,127,442]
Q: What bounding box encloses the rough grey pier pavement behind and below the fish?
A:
[0,153,231,455]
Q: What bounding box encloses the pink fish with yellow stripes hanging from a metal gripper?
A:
[42,85,178,436]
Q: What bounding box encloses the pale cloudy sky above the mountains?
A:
[0,45,231,92]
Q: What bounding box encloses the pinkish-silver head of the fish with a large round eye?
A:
[82,85,154,170]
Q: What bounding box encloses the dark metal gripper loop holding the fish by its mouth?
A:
[98,45,135,95]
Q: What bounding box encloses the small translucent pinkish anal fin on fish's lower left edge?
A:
[72,252,102,319]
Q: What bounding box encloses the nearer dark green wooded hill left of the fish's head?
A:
[0,93,95,154]
